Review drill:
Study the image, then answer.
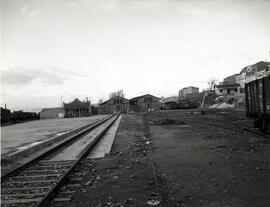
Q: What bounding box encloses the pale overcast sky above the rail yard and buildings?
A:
[0,0,270,110]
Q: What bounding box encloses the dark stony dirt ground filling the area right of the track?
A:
[51,111,270,207]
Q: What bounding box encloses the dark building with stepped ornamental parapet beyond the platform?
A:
[63,98,91,118]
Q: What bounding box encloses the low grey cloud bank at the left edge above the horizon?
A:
[2,66,69,86]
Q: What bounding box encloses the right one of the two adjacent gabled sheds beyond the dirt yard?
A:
[129,94,161,112]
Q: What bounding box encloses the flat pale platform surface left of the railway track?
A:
[1,115,107,158]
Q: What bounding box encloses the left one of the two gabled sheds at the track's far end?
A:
[98,96,129,114]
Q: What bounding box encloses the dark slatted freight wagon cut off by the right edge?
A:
[245,75,270,132]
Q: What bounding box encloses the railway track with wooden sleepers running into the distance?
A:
[1,115,119,207]
